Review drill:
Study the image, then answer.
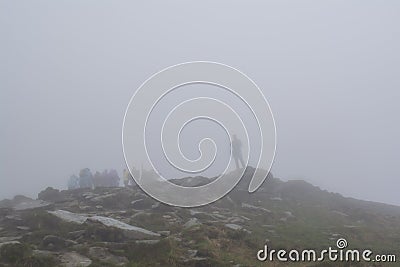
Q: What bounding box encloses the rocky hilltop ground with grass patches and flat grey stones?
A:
[0,169,400,267]
